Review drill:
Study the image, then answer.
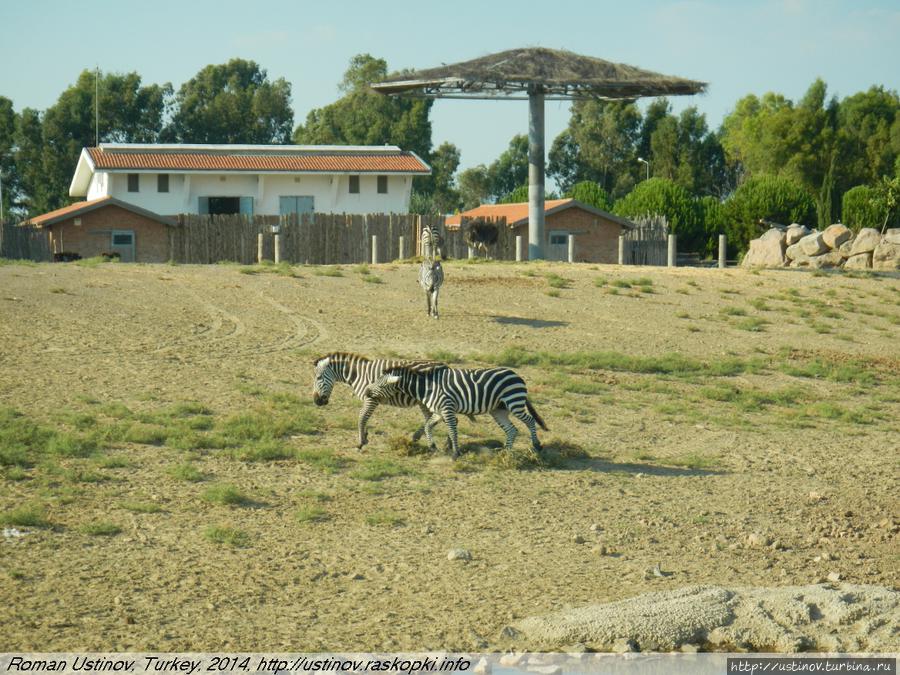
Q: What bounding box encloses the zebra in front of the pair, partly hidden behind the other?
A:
[313,352,431,449]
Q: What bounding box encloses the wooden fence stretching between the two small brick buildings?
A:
[169,213,516,265]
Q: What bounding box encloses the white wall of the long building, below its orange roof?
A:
[87,171,412,216]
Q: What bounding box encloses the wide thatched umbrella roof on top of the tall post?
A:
[372,47,706,100]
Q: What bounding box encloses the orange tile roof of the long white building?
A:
[87,148,430,174]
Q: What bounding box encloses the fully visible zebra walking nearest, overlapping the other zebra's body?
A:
[365,363,547,457]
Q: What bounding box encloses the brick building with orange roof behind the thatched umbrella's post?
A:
[447,199,634,263]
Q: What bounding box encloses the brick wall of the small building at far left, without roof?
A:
[50,205,169,262]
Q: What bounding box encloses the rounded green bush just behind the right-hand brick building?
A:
[613,178,707,251]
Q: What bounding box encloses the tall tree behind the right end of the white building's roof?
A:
[293,54,432,161]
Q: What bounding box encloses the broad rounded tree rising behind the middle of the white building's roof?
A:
[166,59,294,144]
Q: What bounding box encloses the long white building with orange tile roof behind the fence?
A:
[69,143,431,216]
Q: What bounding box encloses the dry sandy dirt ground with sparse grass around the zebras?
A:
[0,263,900,652]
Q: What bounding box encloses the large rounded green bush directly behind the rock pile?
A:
[725,176,817,255]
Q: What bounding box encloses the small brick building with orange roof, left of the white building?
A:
[28,197,174,262]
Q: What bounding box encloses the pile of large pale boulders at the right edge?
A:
[741,223,900,271]
